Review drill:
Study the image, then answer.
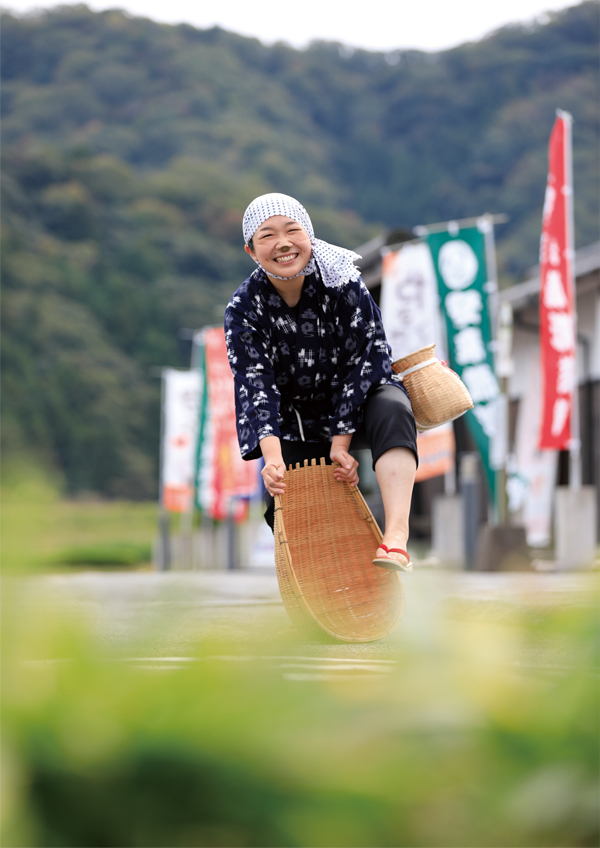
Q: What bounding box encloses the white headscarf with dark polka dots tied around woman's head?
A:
[243,194,361,288]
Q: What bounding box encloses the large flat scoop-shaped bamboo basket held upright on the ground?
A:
[275,459,405,642]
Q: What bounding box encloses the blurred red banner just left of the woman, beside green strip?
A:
[204,327,257,521]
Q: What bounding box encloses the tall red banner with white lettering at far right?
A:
[539,113,577,450]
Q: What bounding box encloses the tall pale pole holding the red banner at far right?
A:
[556,109,581,490]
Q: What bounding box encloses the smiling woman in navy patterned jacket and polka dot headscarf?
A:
[225,194,418,571]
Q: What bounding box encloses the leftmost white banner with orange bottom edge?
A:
[161,368,201,512]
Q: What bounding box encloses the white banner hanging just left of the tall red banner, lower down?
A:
[506,355,558,547]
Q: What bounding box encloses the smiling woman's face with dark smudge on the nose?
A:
[246,215,312,277]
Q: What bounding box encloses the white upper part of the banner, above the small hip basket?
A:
[380,242,446,359]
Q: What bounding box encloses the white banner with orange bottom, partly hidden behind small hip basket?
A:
[380,242,455,482]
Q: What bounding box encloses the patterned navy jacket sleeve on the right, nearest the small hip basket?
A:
[329,279,392,436]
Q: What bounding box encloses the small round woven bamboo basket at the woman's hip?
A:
[392,345,473,430]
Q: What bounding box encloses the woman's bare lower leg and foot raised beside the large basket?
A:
[375,448,417,564]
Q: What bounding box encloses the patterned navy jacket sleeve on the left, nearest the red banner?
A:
[225,293,281,456]
